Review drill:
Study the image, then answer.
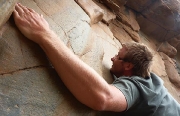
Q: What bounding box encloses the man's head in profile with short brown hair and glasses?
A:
[110,42,153,77]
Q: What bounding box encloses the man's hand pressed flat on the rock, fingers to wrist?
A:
[13,3,51,43]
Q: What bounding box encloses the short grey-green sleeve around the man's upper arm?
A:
[113,78,140,110]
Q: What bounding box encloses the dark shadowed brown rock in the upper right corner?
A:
[126,0,180,41]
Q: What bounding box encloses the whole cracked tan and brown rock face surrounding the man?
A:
[0,0,180,116]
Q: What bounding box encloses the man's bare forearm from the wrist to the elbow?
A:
[40,30,109,107]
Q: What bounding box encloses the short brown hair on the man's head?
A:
[123,42,153,78]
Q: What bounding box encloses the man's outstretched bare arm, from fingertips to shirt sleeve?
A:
[14,4,127,112]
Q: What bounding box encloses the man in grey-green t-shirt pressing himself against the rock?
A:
[13,3,180,116]
